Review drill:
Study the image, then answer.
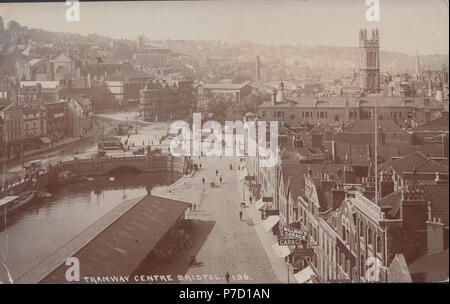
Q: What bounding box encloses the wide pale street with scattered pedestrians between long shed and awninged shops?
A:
[146,157,279,283]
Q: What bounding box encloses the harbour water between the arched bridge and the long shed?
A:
[0,173,180,283]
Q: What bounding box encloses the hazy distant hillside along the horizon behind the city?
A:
[0,21,449,74]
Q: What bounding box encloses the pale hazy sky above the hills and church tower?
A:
[0,0,449,54]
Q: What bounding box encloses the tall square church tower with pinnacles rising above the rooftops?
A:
[359,29,380,94]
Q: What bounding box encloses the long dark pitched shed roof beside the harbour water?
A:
[18,196,189,283]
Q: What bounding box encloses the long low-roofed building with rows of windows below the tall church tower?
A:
[258,96,444,126]
